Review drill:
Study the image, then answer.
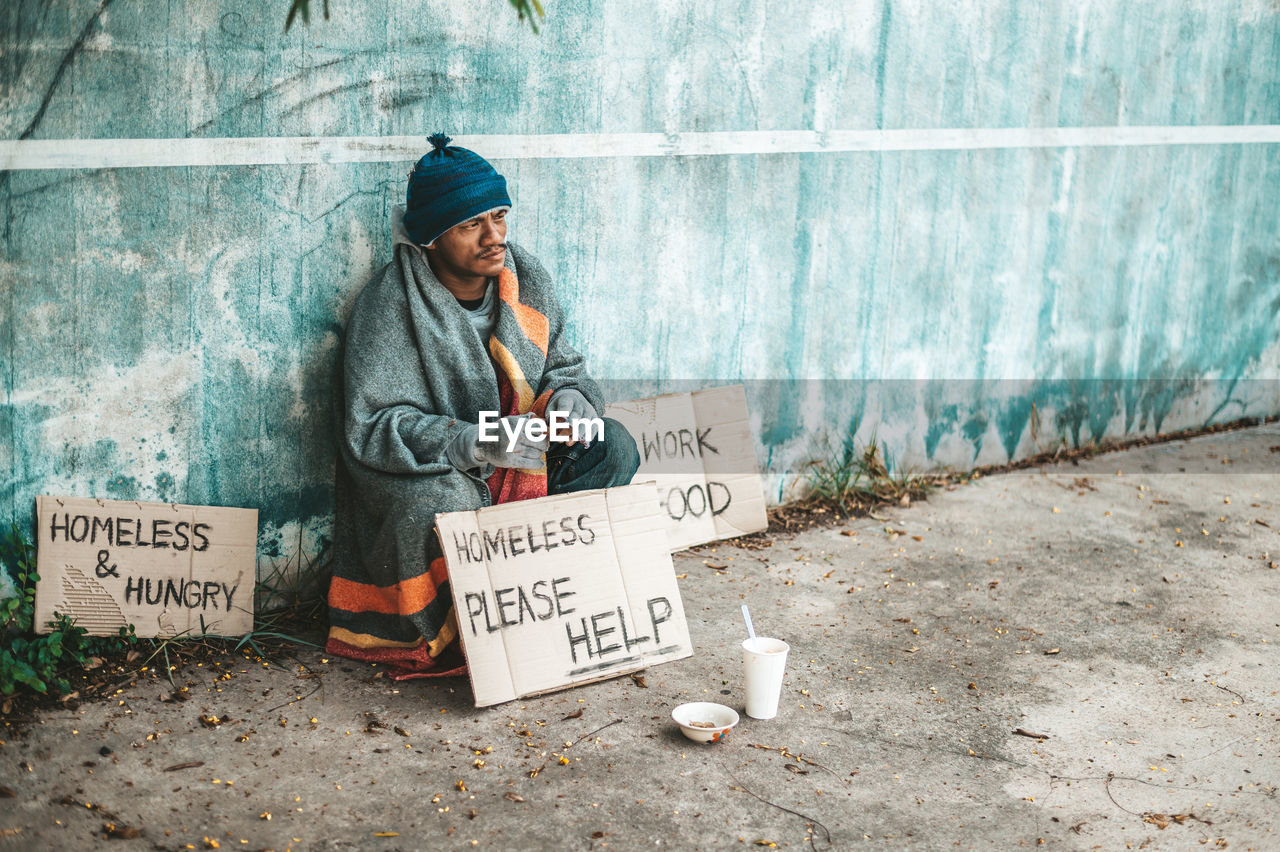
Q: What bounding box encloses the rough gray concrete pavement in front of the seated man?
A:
[0,425,1280,849]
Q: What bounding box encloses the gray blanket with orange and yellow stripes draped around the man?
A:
[329,220,604,670]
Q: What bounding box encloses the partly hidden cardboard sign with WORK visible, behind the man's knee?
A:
[604,385,769,550]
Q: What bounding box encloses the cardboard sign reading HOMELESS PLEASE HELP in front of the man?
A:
[435,482,692,707]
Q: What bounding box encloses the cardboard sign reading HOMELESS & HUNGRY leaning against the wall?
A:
[36,496,257,636]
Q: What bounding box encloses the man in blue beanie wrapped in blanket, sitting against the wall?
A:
[328,134,640,677]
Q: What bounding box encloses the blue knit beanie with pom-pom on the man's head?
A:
[404,133,511,246]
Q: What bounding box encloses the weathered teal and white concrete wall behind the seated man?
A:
[0,0,1280,573]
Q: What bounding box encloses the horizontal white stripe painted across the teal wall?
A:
[0,124,1280,170]
